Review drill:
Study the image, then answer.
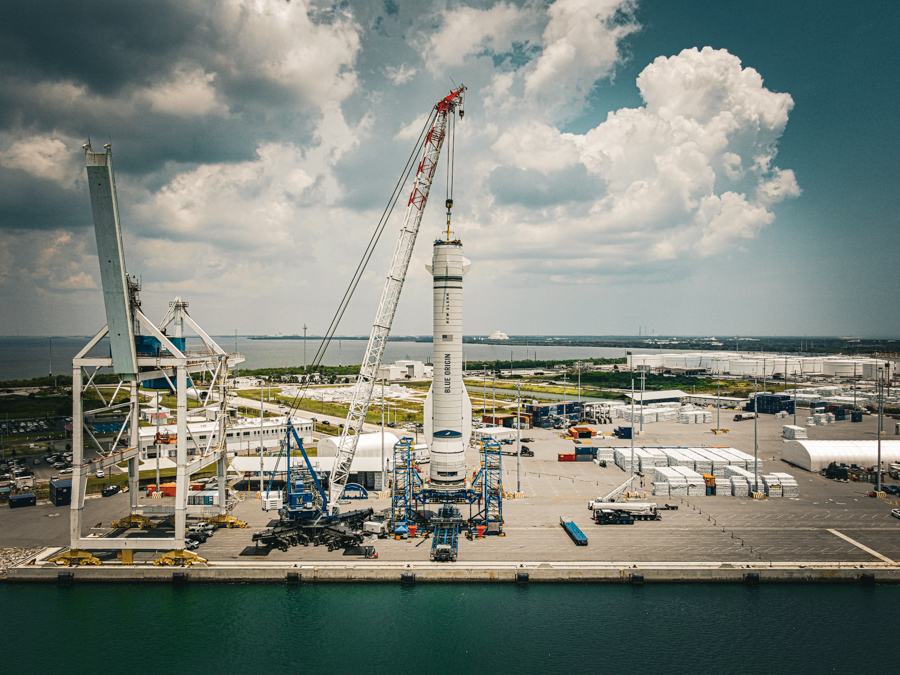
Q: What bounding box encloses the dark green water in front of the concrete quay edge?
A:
[0,584,884,675]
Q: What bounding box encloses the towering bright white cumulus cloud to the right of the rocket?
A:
[468,47,800,275]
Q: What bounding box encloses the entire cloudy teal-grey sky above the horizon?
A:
[0,0,900,337]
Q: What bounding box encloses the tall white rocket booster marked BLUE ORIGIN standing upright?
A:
[425,241,472,487]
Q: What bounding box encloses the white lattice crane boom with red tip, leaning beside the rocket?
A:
[329,86,466,509]
